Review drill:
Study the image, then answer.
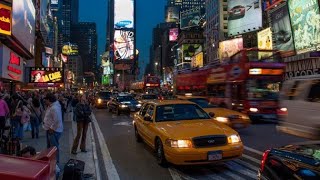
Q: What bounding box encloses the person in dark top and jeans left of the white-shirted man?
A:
[29,97,42,139]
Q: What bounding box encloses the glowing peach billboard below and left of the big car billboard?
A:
[219,38,243,61]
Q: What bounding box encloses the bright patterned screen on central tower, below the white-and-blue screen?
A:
[114,30,134,60]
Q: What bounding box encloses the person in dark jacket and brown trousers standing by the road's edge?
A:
[71,95,92,154]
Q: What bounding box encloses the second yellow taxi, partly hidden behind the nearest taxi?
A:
[178,94,251,129]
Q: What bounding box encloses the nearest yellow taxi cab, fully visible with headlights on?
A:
[133,100,243,165]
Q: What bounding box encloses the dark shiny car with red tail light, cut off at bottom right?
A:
[258,141,320,180]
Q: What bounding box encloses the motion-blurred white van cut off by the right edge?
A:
[278,76,320,139]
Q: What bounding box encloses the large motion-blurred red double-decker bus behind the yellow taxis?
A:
[175,49,285,121]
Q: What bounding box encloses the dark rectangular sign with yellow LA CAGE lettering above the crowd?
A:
[30,67,64,83]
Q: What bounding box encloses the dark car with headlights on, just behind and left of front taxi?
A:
[108,94,141,115]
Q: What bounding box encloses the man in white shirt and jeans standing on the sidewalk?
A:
[43,93,63,164]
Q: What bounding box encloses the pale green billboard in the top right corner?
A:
[288,0,320,54]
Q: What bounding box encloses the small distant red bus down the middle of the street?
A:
[131,75,160,94]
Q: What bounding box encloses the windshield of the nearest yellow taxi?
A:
[156,104,211,122]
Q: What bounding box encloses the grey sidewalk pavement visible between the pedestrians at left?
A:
[22,112,97,180]
